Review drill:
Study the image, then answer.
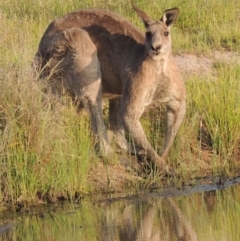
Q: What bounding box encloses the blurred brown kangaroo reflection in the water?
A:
[99,197,200,241]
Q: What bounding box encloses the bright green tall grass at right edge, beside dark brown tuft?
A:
[195,63,240,161]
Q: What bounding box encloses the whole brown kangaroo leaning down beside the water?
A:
[35,6,186,169]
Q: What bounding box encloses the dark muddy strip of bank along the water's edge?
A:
[0,173,240,218]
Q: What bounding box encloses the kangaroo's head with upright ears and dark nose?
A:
[133,6,179,58]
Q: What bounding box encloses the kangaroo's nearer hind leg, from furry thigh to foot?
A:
[64,28,112,156]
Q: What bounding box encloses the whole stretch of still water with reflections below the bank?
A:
[0,179,240,241]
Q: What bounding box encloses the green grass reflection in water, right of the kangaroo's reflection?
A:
[178,186,240,241]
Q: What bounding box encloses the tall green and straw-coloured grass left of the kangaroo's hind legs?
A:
[0,65,94,208]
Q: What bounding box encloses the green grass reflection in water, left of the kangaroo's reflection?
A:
[2,202,102,241]
